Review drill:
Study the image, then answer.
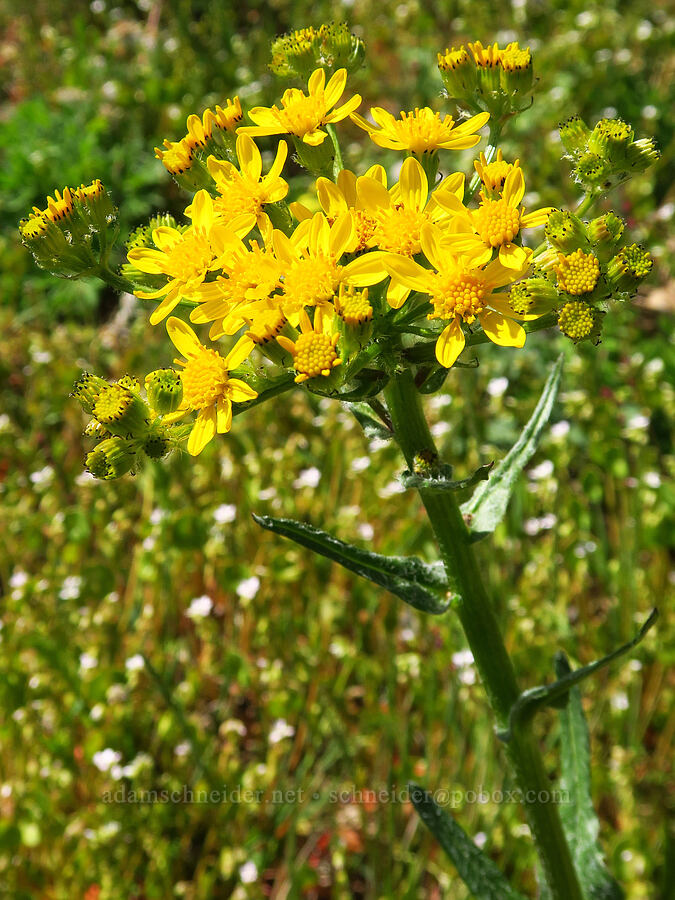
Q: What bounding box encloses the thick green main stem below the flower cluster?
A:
[384,370,582,900]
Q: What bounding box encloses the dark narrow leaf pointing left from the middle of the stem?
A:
[253,515,451,615]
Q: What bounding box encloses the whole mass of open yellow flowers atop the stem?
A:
[120,63,560,454]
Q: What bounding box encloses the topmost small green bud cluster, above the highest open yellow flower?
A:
[269,22,366,79]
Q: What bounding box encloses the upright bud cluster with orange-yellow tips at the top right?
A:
[438,41,534,119]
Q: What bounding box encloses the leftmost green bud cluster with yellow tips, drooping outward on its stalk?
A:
[19,179,119,278]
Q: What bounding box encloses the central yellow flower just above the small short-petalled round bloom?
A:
[273,213,387,325]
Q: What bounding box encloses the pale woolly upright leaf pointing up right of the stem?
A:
[462,354,563,539]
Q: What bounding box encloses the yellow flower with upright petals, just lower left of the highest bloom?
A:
[206,134,288,230]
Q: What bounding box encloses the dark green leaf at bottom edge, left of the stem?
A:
[410,784,525,900]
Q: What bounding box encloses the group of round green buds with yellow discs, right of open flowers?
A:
[509,209,653,344]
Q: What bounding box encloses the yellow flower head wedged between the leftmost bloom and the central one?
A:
[190,240,283,341]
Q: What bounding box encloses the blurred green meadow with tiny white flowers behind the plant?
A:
[0,0,675,900]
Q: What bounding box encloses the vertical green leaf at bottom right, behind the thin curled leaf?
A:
[555,653,624,900]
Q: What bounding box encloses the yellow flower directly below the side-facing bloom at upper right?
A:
[356,157,464,309]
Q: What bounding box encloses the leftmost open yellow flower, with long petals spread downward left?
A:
[128,191,255,325]
